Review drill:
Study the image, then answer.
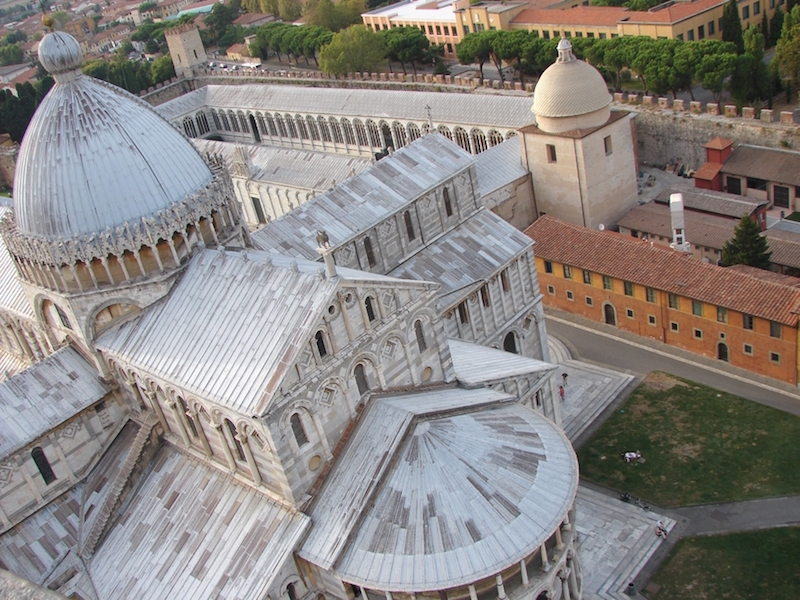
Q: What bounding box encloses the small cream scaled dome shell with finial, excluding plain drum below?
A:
[531,38,611,117]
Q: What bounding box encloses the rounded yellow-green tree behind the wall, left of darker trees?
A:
[319,25,386,75]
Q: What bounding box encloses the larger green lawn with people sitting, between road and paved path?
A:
[578,373,800,506]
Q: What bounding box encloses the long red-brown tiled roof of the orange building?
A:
[525,216,800,327]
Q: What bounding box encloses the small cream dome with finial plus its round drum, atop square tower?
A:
[531,38,611,133]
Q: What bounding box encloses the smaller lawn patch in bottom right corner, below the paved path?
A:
[645,527,800,600]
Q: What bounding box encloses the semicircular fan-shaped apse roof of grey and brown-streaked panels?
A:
[299,388,578,593]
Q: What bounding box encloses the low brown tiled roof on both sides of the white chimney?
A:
[619,202,739,250]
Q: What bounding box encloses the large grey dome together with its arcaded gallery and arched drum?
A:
[2,31,248,370]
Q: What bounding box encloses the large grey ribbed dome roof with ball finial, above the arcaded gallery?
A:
[14,32,212,240]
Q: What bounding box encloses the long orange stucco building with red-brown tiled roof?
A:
[526,216,800,385]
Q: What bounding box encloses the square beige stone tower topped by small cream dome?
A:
[521,38,638,227]
